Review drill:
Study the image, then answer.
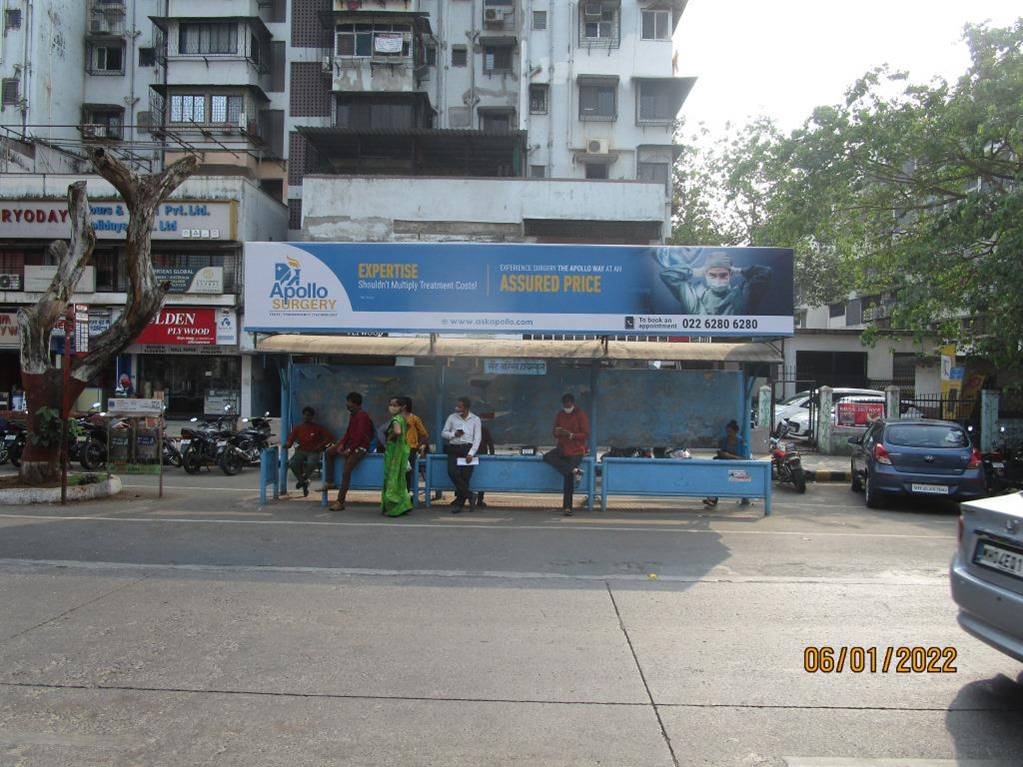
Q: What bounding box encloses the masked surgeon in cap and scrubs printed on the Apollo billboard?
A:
[657,249,771,316]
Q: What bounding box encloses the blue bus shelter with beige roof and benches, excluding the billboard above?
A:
[257,333,781,510]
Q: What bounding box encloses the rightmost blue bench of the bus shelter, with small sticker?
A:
[597,458,771,516]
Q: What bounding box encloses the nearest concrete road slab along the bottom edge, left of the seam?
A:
[0,687,672,767]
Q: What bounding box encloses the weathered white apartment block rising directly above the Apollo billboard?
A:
[286,0,695,242]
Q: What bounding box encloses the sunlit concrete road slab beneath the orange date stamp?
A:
[614,583,1019,709]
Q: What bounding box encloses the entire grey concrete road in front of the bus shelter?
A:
[0,473,1023,767]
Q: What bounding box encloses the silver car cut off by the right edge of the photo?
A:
[950,493,1023,662]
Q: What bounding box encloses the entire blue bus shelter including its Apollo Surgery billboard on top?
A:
[244,242,793,510]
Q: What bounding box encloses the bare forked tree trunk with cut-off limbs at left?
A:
[17,148,198,485]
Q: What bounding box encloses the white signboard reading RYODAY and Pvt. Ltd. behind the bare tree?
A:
[0,199,236,240]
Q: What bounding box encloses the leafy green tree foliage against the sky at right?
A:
[674,19,1023,366]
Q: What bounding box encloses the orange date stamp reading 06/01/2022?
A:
[803,644,959,674]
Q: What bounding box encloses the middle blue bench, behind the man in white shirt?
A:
[427,453,596,510]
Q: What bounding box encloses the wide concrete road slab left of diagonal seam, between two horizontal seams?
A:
[0,573,649,703]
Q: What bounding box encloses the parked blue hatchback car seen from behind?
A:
[849,418,986,508]
